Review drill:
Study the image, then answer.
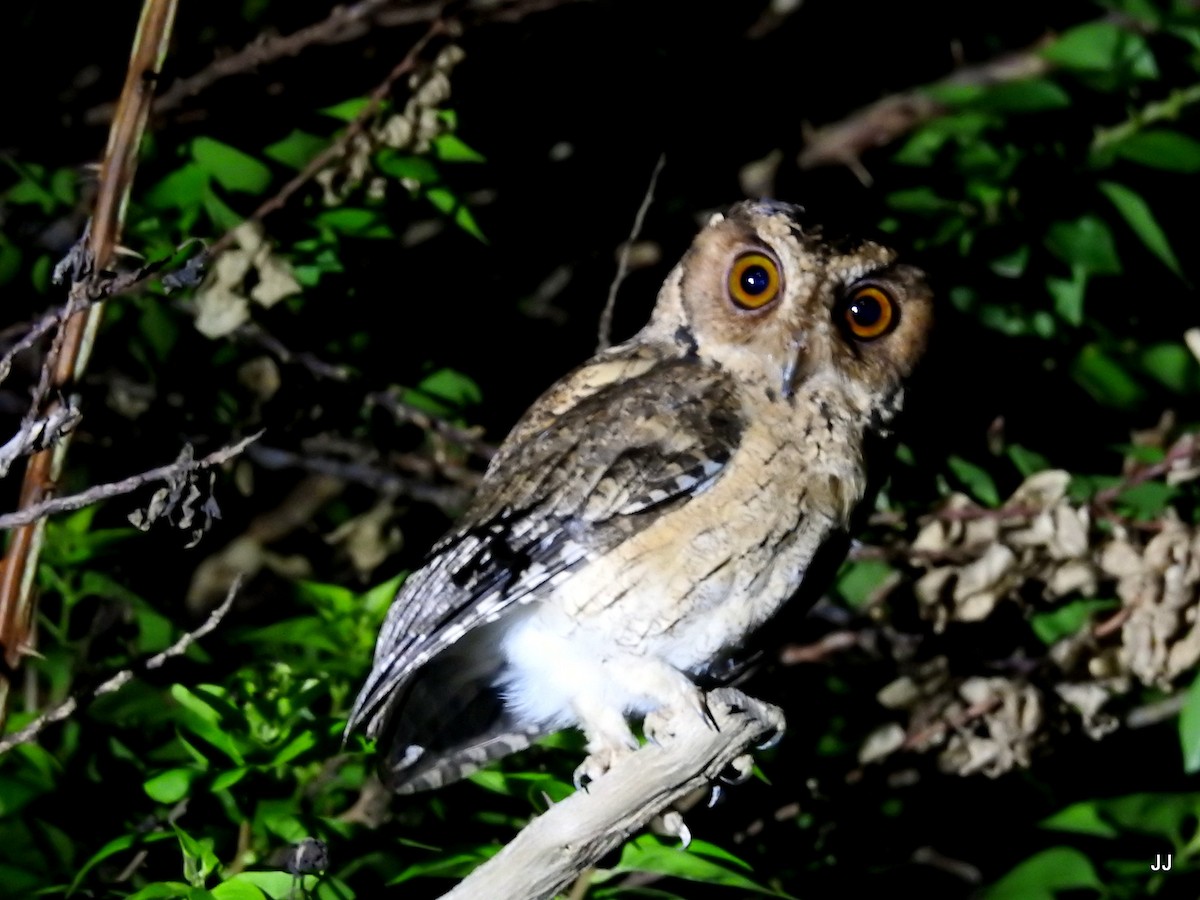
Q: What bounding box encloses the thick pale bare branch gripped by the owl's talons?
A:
[442,688,784,900]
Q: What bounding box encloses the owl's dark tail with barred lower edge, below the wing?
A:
[380,661,550,794]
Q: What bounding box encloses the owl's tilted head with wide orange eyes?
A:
[647,202,932,434]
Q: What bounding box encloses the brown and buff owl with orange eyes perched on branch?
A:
[348,202,932,793]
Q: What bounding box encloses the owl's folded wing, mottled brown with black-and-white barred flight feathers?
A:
[347,359,742,737]
